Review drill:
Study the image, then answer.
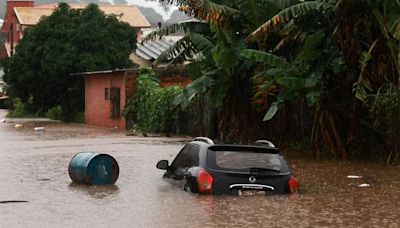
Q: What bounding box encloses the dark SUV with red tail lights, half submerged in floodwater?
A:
[157,137,300,195]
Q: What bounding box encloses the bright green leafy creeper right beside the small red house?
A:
[124,69,219,135]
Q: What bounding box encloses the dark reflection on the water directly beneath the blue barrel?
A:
[68,182,119,199]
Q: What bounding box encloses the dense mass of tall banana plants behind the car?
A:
[148,0,400,161]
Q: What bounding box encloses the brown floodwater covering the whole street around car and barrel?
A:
[0,110,400,228]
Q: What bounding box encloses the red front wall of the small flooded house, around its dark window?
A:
[85,72,126,129]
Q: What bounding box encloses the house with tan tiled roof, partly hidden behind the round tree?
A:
[0,0,151,58]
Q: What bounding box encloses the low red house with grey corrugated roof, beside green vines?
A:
[79,25,192,129]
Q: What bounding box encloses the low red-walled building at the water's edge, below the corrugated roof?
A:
[78,67,191,129]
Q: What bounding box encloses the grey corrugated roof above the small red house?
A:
[136,36,182,61]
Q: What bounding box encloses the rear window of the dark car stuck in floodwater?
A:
[207,148,288,172]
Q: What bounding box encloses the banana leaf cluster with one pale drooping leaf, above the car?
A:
[242,30,325,121]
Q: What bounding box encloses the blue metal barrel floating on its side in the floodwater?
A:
[68,152,119,185]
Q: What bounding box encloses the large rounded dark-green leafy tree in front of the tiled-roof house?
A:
[4,4,136,119]
